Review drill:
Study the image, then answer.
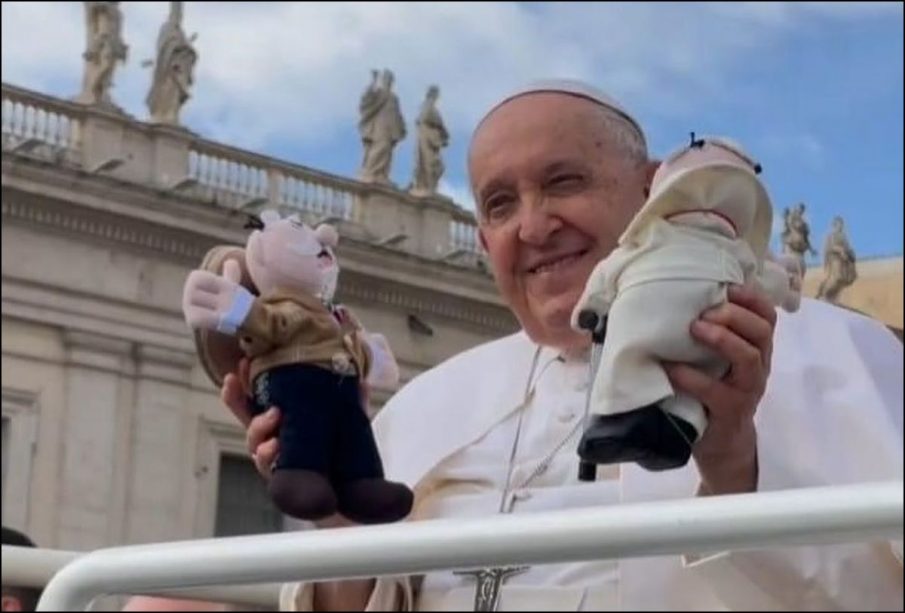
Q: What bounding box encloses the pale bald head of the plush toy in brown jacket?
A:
[245,211,339,302]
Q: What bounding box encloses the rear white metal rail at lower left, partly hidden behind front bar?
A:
[2,545,281,609]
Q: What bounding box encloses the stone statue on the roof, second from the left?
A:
[146,2,198,125]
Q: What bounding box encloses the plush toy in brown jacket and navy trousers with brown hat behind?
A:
[183,211,412,523]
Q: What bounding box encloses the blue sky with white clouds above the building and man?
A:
[2,1,903,257]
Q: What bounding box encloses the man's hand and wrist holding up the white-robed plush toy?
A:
[666,286,776,494]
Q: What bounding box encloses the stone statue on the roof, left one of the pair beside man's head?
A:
[358,70,405,184]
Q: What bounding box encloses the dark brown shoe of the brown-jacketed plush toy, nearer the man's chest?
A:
[337,479,414,524]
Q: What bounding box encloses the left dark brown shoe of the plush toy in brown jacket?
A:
[269,468,336,521]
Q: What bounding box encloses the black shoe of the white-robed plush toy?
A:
[578,404,698,471]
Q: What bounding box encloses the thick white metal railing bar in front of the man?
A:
[31,481,903,611]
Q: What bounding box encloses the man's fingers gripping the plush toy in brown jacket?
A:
[220,359,280,479]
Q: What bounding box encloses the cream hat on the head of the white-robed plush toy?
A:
[619,135,773,259]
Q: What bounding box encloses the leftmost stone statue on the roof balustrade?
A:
[76,2,129,110]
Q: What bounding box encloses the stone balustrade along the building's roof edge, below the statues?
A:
[2,83,481,266]
